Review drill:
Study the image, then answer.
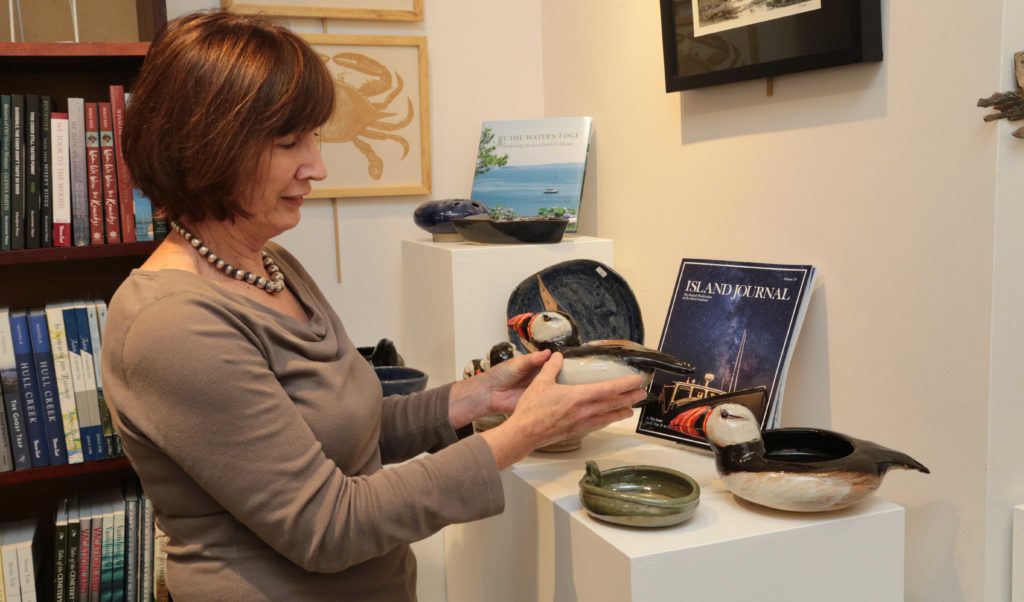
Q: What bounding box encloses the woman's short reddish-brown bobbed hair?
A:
[123,12,334,222]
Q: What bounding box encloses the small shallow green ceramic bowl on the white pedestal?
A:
[580,461,700,527]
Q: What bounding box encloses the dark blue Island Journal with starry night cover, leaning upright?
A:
[636,259,816,448]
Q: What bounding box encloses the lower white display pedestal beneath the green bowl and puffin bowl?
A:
[444,418,904,602]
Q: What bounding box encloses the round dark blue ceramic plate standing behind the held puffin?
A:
[507,259,643,352]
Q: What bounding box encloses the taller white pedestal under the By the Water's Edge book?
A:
[398,237,612,385]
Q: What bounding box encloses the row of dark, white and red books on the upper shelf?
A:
[0,85,166,251]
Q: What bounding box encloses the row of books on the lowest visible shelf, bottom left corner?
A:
[0,481,168,602]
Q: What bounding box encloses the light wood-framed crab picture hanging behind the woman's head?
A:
[302,34,430,199]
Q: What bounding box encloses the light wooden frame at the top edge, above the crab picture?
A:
[220,0,423,20]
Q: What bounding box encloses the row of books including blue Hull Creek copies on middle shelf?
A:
[0,301,123,472]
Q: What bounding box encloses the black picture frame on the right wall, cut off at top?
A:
[662,0,883,92]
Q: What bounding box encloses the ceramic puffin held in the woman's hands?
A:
[508,311,693,384]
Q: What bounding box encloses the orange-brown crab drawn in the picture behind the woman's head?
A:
[321,52,413,180]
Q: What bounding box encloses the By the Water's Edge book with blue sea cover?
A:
[470,117,592,232]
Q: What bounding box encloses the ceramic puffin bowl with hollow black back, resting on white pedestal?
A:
[705,403,930,512]
